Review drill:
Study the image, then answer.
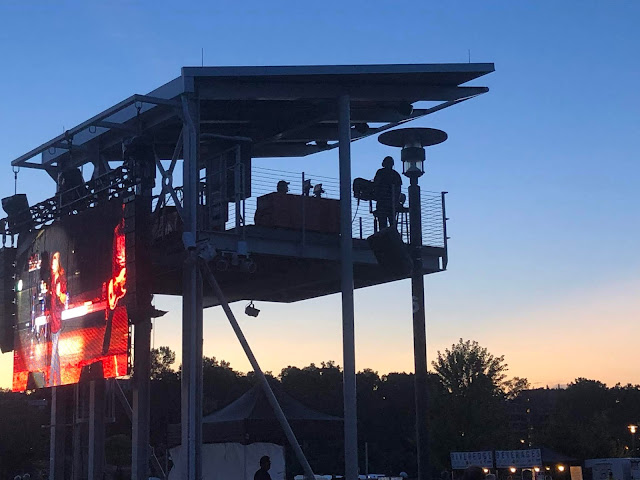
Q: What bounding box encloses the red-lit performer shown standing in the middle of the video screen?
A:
[49,252,67,386]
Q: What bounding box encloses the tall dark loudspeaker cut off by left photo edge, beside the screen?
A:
[0,248,16,353]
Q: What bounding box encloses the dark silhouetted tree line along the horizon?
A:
[0,339,640,477]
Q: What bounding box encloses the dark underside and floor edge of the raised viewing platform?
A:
[153,225,446,307]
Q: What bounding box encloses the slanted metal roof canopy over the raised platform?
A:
[11,63,494,174]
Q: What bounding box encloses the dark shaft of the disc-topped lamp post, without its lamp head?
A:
[409,177,429,480]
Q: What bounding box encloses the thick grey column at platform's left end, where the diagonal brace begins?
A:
[181,96,202,480]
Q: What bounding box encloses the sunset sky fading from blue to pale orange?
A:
[0,0,640,386]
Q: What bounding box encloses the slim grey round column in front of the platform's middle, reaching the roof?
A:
[338,95,358,480]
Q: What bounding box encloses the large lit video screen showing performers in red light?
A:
[13,201,129,391]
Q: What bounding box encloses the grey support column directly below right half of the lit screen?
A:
[88,379,105,480]
